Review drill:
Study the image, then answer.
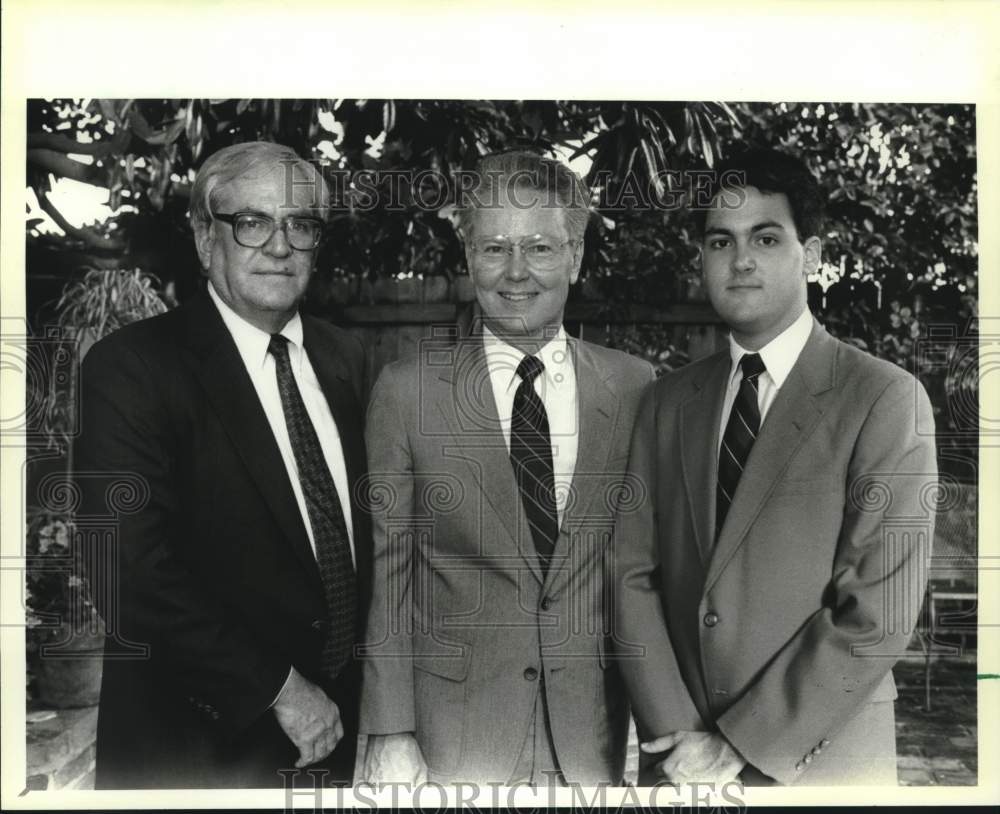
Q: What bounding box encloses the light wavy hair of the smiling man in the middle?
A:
[455,150,590,240]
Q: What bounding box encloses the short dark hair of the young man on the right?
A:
[693,149,826,242]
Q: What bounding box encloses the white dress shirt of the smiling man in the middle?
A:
[483,327,580,526]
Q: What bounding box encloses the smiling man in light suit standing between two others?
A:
[361,152,653,784]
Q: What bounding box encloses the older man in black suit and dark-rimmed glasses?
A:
[76,142,370,788]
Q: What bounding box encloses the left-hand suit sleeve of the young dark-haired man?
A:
[614,384,706,740]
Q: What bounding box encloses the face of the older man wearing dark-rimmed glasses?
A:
[196,165,317,333]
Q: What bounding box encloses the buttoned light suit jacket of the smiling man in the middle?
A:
[361,337,653,783]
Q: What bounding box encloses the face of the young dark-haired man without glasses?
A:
[702,187,820,350]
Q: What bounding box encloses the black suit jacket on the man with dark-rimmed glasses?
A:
[75,293,371,788]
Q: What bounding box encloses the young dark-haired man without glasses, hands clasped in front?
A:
[616,151,936,785]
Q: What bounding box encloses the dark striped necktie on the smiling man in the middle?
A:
[510,356,559,573]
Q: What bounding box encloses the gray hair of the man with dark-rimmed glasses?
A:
[188,141,330,229]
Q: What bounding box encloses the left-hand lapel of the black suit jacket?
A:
[181,294,320,584]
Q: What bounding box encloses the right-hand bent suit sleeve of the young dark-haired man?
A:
[717,377,937,784]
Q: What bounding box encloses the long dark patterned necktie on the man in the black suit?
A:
[267,334,357,678]
